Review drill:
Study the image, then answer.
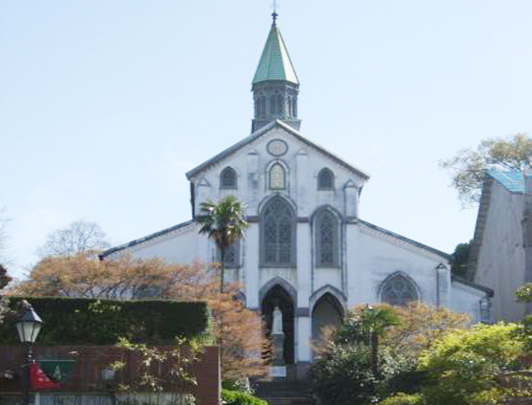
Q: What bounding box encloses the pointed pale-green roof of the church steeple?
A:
[253,19,299,85]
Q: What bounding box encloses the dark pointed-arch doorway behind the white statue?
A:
[261,284,294,364]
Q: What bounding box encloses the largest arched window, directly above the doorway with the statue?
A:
[260,197,296,266]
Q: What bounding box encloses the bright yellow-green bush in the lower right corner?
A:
[419,323,525,405]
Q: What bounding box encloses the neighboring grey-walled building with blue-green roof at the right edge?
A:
[468,170,532,321]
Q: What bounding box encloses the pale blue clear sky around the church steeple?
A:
[0,0,532,276]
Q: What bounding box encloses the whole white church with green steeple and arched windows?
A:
[104,15,492,376]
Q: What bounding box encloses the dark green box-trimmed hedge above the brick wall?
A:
[0,297,210,345]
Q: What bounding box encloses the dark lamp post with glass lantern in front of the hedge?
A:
[16,300,43,405]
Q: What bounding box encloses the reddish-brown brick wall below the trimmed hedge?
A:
[0,346,220,405]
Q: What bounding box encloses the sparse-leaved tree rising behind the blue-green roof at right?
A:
[440,134,532,205]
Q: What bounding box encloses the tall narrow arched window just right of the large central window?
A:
[316,210,340,267]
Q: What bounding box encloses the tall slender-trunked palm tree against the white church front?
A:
[196,195,248,292]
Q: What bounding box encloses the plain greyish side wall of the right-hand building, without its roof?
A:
[475,181,525,321]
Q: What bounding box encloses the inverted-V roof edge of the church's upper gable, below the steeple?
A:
[186,120,369,180]
